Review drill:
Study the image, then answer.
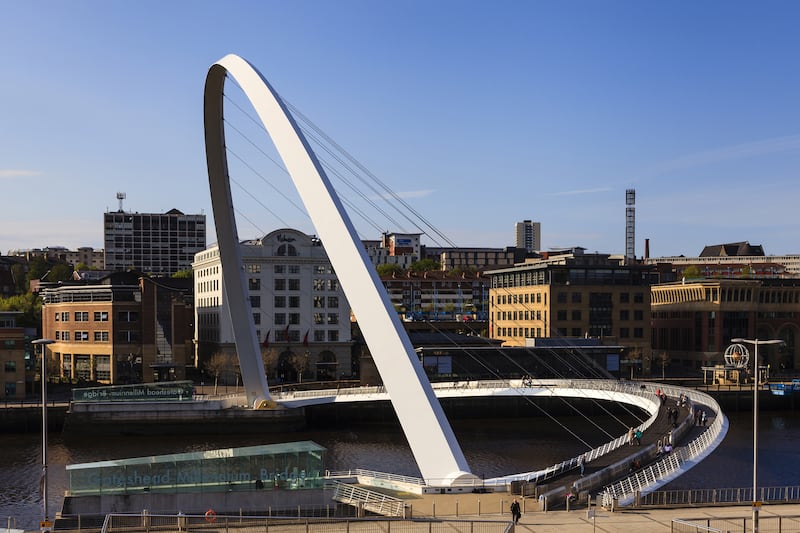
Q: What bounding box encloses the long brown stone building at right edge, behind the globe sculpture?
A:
[651,278,800,374]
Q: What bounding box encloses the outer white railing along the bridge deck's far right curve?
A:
[600,386,728,507]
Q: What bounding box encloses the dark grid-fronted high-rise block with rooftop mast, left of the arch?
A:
[103,205,206,276]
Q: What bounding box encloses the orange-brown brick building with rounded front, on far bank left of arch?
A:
[41,272,194,384]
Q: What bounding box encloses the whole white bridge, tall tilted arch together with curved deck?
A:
[198,55,727,501]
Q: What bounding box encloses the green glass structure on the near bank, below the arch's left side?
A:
[67,441,325,496]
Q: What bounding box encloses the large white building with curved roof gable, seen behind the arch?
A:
[192,229,352,383]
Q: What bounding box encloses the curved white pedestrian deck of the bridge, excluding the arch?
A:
[273,379,728,506]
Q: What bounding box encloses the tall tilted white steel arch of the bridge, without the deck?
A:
[204,54,475,485]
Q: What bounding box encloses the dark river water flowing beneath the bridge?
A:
[0,411,800,530]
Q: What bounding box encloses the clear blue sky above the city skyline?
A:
[0,0,800,257]
